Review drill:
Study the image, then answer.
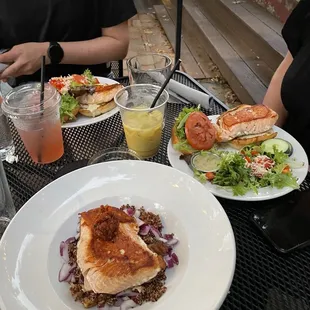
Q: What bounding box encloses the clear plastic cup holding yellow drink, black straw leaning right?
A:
[114,84,169,159]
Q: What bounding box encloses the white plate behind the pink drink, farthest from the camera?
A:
[61,76,119,128]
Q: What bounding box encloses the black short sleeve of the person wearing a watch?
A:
[97,0,137,28]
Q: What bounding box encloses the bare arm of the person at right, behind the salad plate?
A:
[263,52,293,127]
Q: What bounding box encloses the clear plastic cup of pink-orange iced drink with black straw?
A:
[2,83,64,164]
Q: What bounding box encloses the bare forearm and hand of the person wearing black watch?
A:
[0,21,129,79]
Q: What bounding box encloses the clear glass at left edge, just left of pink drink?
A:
[0,81,15,161]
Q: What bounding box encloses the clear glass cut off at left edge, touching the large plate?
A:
[0,161,16,239]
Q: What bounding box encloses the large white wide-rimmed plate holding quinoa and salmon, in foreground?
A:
[0,161,236,310]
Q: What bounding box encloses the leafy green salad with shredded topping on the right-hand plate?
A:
[194,145,299,196]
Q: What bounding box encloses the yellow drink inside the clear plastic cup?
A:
[123,110,164,158]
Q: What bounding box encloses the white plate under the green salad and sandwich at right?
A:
[167,115,308,201]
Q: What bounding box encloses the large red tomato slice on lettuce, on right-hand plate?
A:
[185,112,216,150]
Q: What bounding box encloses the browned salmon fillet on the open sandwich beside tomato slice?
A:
[214,104,278,142]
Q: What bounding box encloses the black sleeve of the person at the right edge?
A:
[282,0,310,57]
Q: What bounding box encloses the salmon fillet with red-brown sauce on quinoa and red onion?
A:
[77,206,166,294]
